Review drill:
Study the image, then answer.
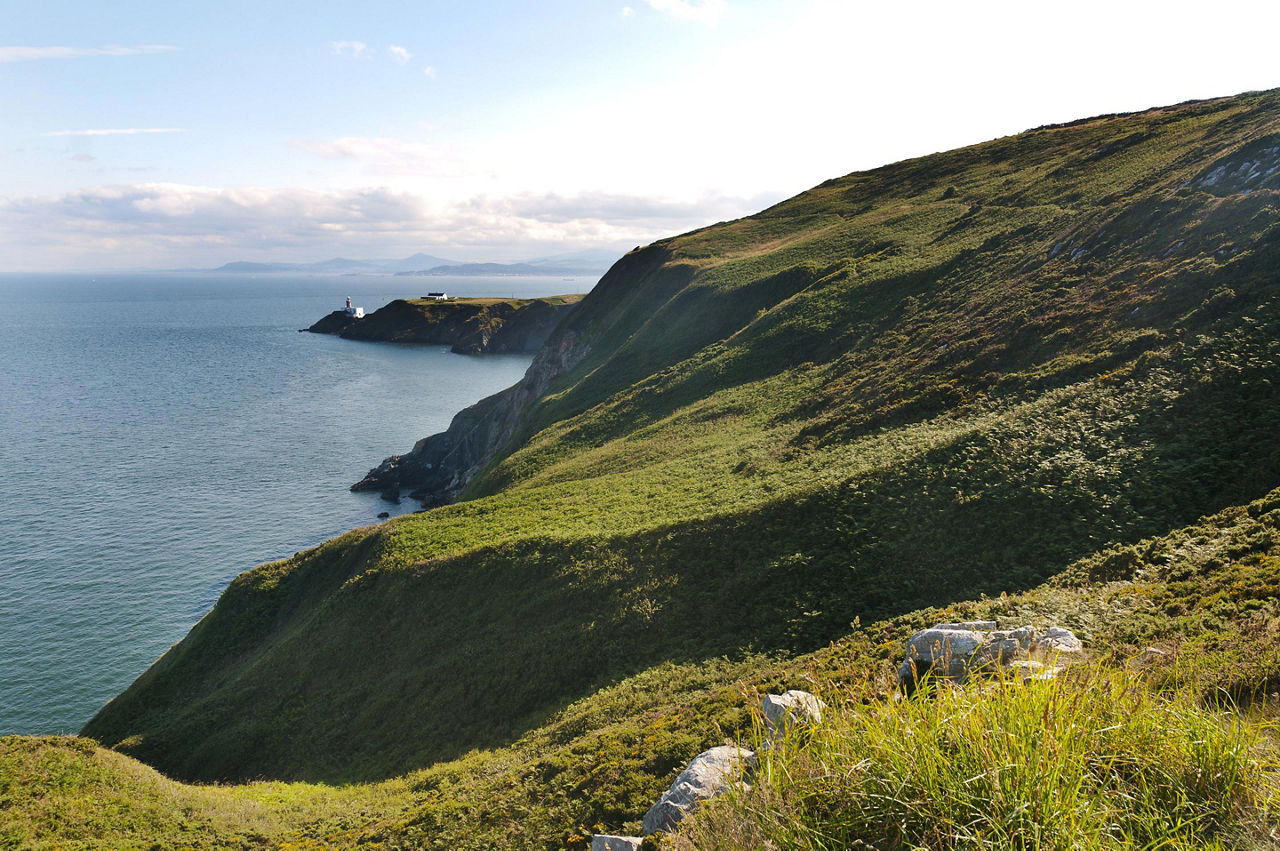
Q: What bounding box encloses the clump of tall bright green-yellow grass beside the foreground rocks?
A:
[664,668,1280,851]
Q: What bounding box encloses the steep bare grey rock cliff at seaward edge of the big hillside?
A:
[343,246,668,507]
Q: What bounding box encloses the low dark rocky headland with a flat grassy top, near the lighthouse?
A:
[307,294,582,354]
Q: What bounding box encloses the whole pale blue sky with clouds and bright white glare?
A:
[0,0,1280,271]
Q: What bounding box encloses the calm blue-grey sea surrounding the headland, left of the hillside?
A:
[0,274,594,735]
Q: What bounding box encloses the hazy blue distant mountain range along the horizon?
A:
[211,248,620,275]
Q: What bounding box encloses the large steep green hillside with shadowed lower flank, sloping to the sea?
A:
[86,84,1280,781]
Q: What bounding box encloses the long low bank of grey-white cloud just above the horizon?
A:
[0,183,750,269]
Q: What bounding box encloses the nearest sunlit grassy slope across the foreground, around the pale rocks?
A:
[10,489,1280,848]
